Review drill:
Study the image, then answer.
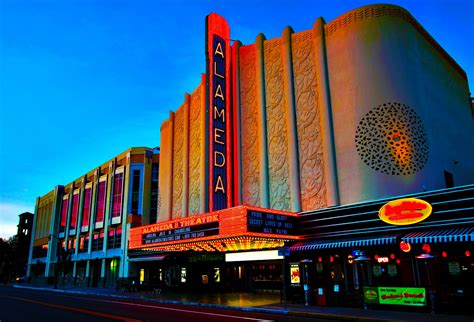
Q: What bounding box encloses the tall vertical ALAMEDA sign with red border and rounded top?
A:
[206,13,232,211]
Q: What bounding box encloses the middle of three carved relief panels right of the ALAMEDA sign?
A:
[263,38,291,210]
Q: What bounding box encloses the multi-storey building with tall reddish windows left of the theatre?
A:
[27,148,159,287]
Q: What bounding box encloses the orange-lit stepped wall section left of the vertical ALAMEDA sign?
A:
[158,79,207,221]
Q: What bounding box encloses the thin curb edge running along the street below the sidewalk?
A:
[12,284,397,322]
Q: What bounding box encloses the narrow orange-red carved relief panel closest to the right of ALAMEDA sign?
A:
[240,45,260,206]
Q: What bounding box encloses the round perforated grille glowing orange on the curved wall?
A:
[355,103,428,175]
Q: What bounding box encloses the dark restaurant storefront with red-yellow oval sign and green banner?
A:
[288,186,474,312]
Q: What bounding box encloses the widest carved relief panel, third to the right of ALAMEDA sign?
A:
[291,30,327,211]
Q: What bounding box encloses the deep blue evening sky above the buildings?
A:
[0,0,474,237]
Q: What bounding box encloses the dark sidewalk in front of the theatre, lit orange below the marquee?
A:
[13,284,474,322]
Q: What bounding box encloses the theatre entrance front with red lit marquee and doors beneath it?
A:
[129,206,298,291]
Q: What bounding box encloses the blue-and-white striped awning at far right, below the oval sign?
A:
[402,227,474,244]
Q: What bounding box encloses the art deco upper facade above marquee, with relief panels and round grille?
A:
[159,5,474,221]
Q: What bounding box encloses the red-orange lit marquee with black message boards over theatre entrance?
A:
[129,206,298,251]
